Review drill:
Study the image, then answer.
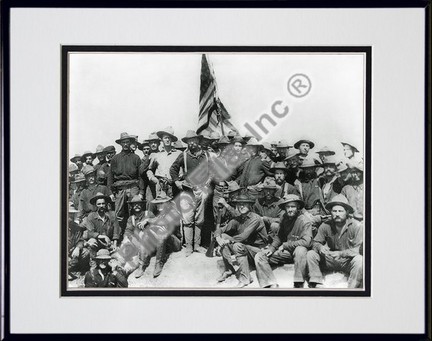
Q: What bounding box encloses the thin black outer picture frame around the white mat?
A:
[1,0,431,340]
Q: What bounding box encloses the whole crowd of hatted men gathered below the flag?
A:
[68,127,363,288]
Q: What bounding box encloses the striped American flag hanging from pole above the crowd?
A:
[197,54,238,135]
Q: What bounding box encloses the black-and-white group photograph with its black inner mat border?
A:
[62,46,371,295]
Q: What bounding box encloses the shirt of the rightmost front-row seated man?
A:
[313,219,363,257]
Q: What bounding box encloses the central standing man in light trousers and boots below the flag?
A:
[170,130,211,257]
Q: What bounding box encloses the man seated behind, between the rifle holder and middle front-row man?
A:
[252,177,283,240]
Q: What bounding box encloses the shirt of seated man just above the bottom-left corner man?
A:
[84,212,120,240]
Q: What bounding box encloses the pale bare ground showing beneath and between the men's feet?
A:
[69,249,347,290]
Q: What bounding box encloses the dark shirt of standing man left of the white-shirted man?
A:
[108,151,141,188]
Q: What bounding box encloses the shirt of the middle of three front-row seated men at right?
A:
[270,214,312,253]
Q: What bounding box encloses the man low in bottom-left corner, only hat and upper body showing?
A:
[84,249,128,288]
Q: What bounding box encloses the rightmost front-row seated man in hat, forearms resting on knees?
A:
[306,194,363,288]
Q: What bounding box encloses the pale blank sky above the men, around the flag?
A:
[69,52,365,156]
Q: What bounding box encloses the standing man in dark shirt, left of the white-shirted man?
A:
[108,133,144,231]
